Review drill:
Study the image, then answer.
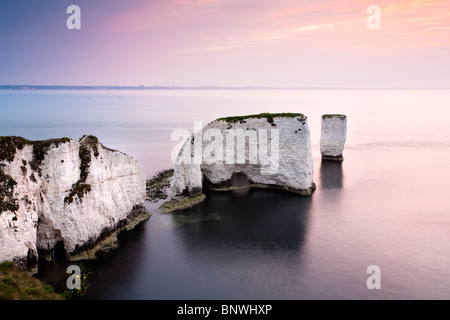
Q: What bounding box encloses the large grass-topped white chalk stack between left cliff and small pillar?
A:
[171,114,315,202]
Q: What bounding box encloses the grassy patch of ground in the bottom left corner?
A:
[0,261,64,300]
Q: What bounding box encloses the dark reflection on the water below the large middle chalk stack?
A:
[172,189,311,253]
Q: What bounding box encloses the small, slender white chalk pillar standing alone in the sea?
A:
[320,114,347,161]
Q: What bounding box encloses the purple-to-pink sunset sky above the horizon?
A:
[0,0,450,88]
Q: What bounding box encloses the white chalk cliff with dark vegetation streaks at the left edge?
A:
[0,136,149,263]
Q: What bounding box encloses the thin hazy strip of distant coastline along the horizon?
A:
[0,85,450,90]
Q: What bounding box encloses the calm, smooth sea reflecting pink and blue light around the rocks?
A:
[0,90,450,299]
